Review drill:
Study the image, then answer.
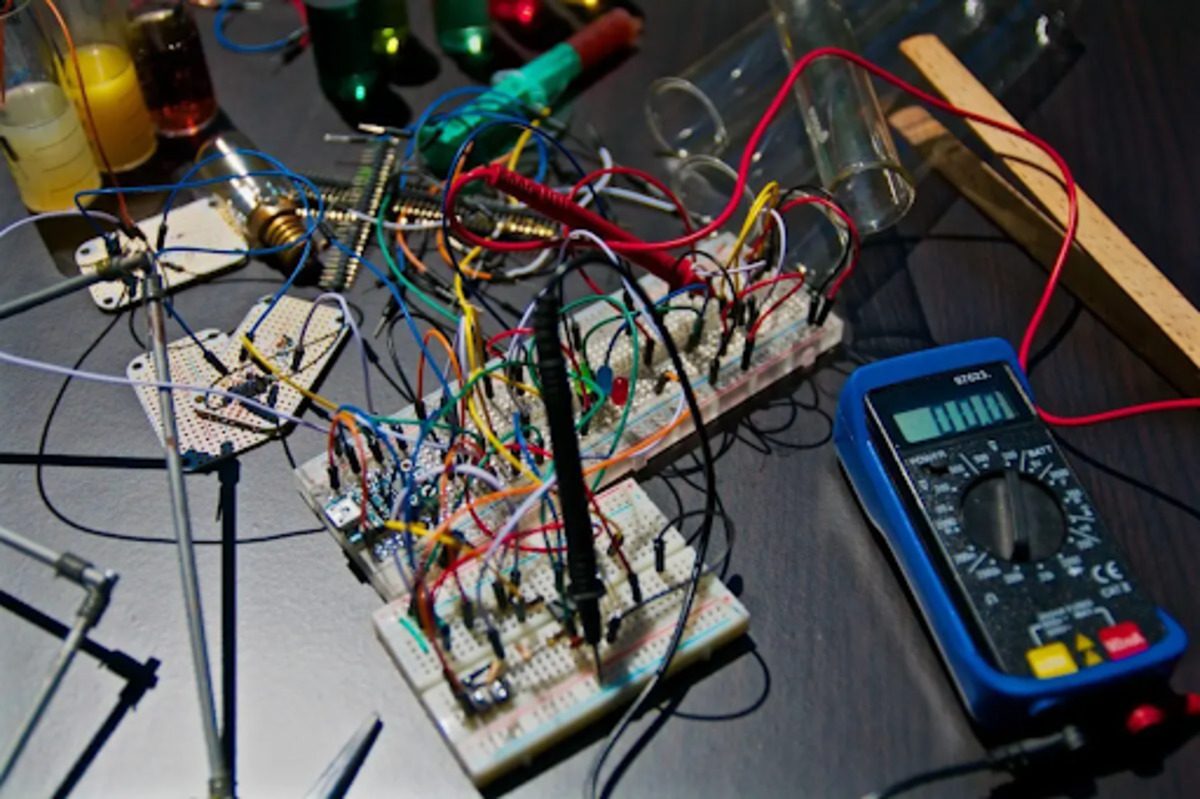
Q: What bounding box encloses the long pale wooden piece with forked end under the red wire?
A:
[890,35,1200,396]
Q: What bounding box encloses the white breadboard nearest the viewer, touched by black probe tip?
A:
[374,480,750,786]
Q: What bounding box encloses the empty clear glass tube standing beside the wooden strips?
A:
[770,0,916,234]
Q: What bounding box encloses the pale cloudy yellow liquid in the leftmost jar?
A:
[0,82,100,212]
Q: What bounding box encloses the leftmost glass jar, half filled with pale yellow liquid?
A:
[0,0,100,212]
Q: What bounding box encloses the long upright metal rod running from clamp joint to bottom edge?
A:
[143,270,233,798]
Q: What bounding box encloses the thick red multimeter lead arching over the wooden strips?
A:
[448,47,1200,426]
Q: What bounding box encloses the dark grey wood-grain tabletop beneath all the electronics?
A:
[0,0,1200,797]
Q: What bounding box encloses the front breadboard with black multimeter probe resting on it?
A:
[374,481,749,785]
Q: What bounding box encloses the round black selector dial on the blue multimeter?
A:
[962,469,1067,563]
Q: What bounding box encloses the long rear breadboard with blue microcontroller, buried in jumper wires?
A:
[296,276,842,600]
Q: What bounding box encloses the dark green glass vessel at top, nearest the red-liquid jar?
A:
[304,0,384,106]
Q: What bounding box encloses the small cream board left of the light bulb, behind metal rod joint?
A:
[76,198,247,312]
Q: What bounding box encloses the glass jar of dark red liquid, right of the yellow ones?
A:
[128,0,217,137]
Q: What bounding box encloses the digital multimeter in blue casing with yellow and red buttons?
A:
[834,338,1187,727]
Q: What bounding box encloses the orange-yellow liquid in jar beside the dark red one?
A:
[61,44,158,172]
